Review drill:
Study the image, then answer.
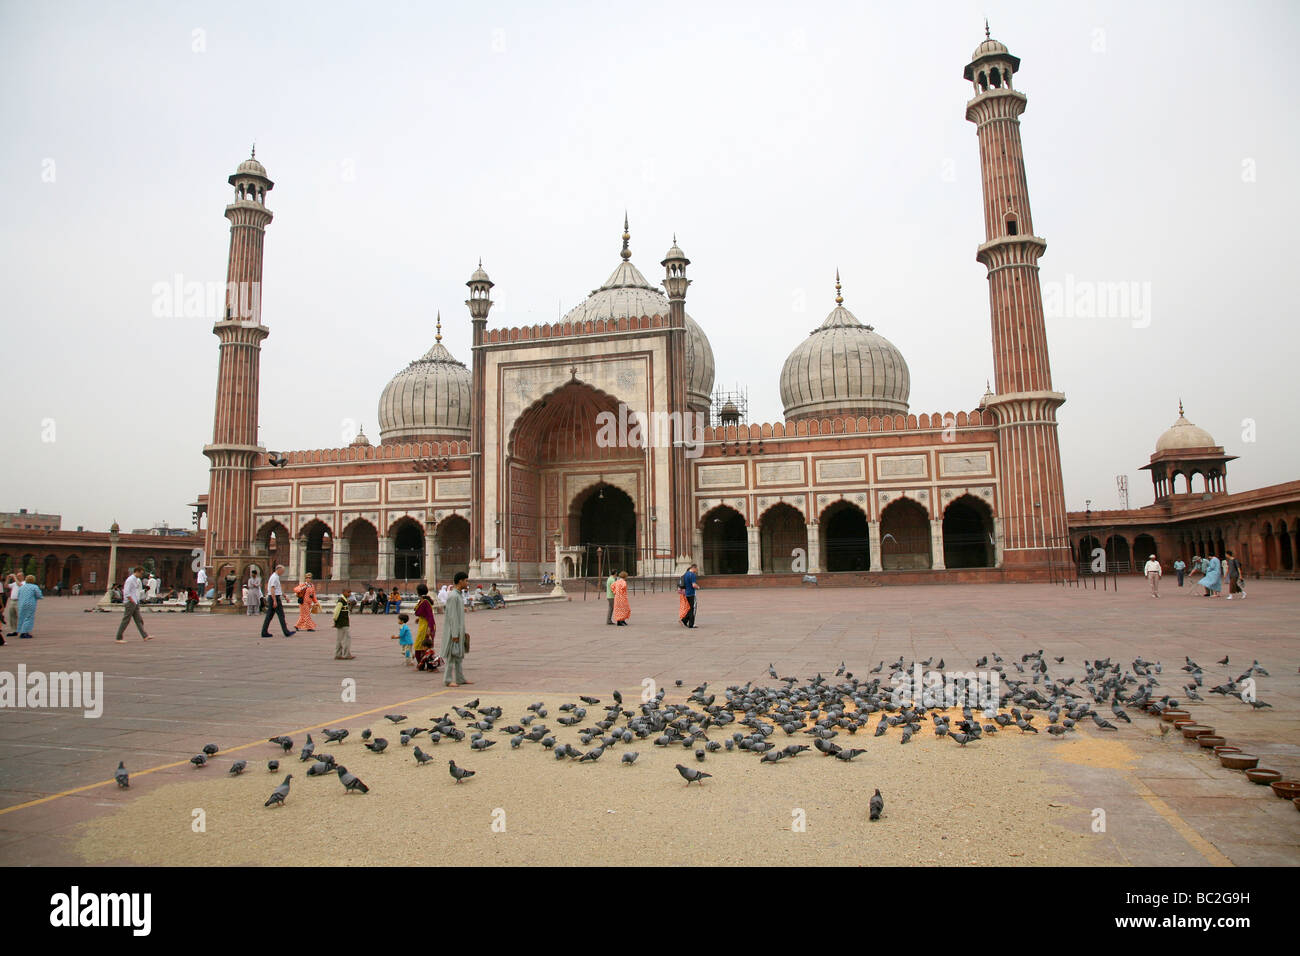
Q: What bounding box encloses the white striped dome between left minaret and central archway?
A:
[380,319,473,445]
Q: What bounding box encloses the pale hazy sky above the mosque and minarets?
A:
[0,0,1300,529]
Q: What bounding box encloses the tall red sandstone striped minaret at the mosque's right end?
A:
[965,23,1069,567]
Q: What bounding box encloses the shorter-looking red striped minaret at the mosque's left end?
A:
[203,150,276,574]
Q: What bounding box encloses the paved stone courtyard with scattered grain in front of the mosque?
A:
[0,579,1300,866]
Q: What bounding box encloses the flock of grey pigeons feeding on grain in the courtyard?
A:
[116,650,1270,821]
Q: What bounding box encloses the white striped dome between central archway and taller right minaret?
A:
[781,278,911,420]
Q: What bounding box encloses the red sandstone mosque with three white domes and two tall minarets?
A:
[199,31,1073,583]
